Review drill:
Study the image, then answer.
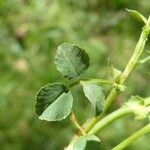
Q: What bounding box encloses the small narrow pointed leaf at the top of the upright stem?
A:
[126,9,147,24]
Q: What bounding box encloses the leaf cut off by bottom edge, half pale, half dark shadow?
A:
[73,135,101,150]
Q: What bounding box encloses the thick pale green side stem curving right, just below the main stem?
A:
[88,107,134,134]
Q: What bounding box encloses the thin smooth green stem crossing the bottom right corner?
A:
[112,124,150,150]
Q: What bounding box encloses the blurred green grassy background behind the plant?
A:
[0,0,150,150]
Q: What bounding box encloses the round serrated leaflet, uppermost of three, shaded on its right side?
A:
[55,43,89,79]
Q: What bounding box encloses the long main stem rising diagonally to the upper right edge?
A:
[85,17,150,132]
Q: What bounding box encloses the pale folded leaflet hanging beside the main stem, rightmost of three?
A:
[80,81,105,116]
